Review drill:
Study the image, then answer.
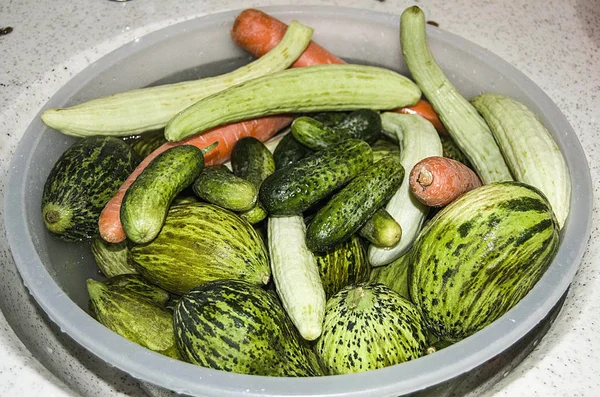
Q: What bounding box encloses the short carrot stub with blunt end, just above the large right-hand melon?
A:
[409,156,481,207]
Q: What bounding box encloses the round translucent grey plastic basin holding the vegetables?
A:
[5,6,592,397]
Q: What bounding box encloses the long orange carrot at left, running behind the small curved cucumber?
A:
[98,115,293,243]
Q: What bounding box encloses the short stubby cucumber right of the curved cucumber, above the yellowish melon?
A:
[193,165,258,211]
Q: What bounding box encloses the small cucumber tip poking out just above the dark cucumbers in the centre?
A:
[292,116,351,151]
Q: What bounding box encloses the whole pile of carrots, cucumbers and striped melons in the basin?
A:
[42,6,570,376]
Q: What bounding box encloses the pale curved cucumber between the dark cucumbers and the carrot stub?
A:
[368,112,442,266]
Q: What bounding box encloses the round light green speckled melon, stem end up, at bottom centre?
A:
[316,283,427,374]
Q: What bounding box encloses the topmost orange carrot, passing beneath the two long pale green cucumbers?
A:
[231,8,446,133]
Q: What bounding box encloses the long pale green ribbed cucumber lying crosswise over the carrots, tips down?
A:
[165,64,421,141]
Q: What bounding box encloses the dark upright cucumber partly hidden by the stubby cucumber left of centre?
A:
[231,137,275,224]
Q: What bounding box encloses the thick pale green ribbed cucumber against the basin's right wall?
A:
[471,93,571,228]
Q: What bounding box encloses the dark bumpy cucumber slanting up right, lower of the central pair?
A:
[306,157,404,252]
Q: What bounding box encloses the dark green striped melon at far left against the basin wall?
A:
[41,137,137,241]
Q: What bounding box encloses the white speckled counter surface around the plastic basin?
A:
[0,0,600,397]
